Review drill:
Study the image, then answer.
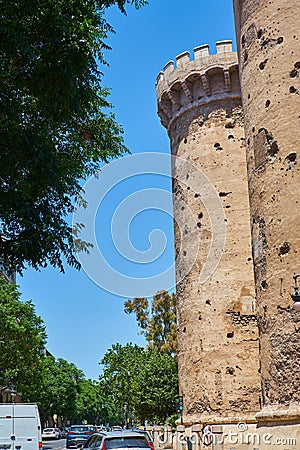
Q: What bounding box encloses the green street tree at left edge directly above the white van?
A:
[0,276,46,393]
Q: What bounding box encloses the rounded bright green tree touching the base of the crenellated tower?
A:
[100,344,178,423]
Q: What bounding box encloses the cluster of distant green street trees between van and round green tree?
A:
[27,354,119,425]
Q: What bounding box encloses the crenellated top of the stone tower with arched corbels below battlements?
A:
[156,41,241,130]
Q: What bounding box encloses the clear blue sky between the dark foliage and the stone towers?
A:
[17,0,235,379]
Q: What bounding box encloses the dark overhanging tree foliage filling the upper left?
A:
[0,0,146,272]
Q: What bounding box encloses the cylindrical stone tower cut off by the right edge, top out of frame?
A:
[234,0,300,418]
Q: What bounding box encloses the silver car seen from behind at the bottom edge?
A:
[83,430,151,450]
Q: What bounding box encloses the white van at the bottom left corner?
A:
[0,403,43,450]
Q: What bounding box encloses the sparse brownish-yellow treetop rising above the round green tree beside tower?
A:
[124,291,177,355]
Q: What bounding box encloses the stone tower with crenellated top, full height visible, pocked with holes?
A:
[156,41,260,424]
